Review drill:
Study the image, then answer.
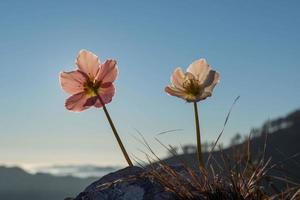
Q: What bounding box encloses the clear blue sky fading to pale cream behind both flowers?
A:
[0,0,300,169]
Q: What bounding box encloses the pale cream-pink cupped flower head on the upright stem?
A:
[165,59,220,102]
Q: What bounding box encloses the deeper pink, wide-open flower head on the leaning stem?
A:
[59,50,118,112]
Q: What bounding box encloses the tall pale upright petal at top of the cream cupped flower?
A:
[187,58,210,84]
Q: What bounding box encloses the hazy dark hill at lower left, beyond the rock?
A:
[0,167,97,200]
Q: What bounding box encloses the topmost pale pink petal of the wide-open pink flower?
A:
[76,50,100,79]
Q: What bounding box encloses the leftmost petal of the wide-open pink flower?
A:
[59,71,86,94]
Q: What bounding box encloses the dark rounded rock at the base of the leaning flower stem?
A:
[68,167,176,200]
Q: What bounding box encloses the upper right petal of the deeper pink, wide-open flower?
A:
[96,60,118,83]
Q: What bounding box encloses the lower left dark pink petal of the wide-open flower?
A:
[65,92,90,112]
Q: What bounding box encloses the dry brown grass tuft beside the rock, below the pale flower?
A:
[144,140,300,200]
